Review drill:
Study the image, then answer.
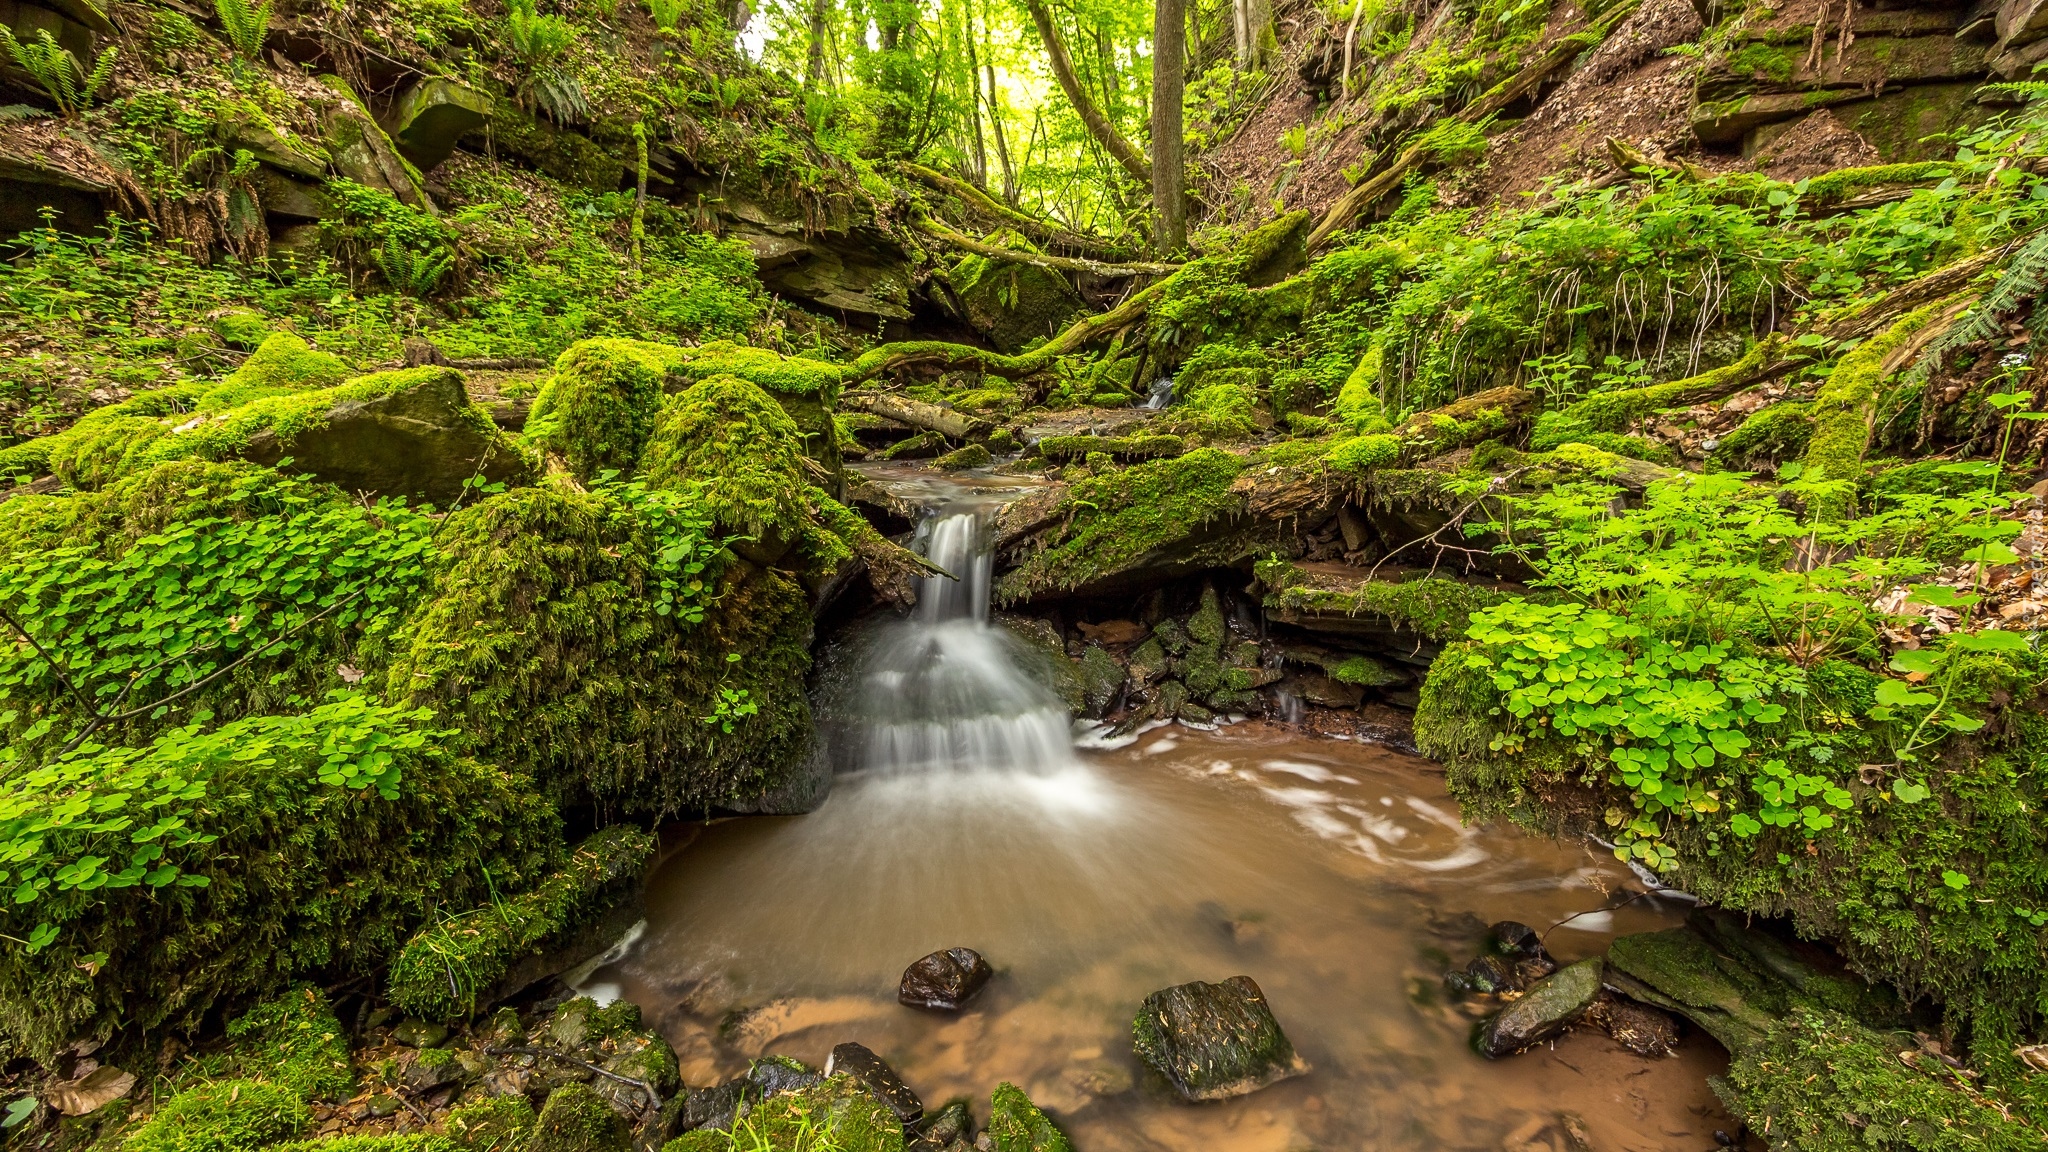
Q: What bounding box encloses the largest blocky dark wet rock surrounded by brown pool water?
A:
[1130,976,1302,1101]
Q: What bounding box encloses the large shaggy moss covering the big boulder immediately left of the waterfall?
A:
[387,479,811,811]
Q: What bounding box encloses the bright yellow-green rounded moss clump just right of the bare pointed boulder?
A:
[526,338,686,482]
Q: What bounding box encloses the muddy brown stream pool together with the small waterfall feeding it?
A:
[594,467,1735,1152]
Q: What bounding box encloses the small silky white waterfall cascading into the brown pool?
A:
[854,504,1075,775]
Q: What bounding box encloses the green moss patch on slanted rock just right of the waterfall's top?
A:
[997,449,1243,603]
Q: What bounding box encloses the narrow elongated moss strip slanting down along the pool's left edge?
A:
[387,826,653,1012]
